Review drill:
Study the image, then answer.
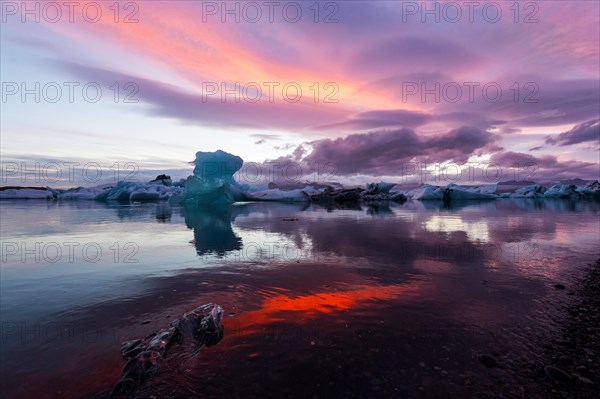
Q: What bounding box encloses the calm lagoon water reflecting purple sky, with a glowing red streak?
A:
[0,200,600,398]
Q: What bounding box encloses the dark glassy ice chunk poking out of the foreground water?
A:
[110,303,223,398]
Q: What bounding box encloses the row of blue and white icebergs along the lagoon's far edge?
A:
[0,150,600,204]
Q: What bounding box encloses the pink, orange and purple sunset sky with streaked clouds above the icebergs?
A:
[1,1,600,184]
